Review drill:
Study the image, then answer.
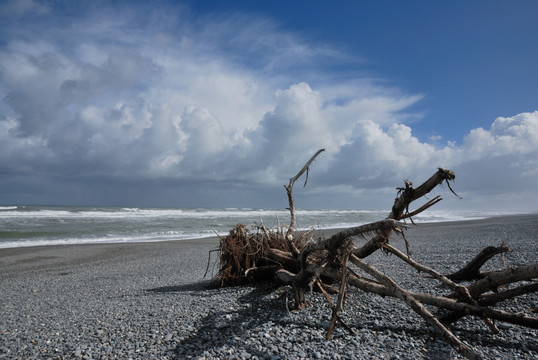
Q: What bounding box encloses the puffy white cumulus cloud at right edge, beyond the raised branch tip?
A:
[455,111,538,205]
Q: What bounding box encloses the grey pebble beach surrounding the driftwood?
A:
[0,215,538,359]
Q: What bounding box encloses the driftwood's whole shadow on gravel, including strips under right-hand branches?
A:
[146,281,538,360]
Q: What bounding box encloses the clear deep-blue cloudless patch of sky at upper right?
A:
[192,1,538,141]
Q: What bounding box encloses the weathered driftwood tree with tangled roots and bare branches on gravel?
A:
[207,149,538,359]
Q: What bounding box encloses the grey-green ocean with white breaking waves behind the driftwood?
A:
[0,206,504,248]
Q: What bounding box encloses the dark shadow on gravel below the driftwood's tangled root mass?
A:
[169,284,288,359]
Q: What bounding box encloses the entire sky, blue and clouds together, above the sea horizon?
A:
[0,0,538,211]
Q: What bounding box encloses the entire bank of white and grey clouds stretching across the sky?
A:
[0,2,538,210]
